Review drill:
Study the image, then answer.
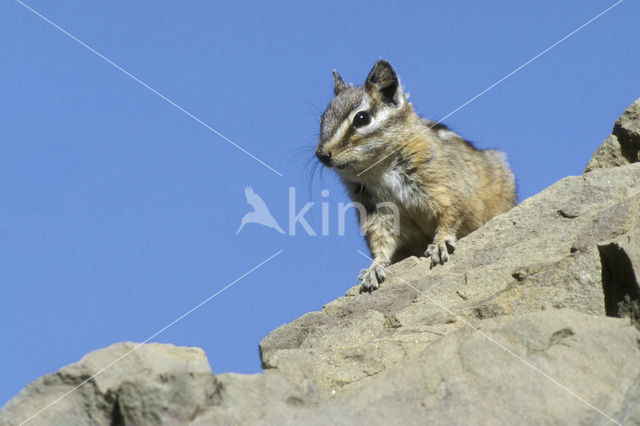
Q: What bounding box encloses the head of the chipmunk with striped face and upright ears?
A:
[316,60,412,178]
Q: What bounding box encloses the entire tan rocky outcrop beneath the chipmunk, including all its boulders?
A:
[0,103,640,425]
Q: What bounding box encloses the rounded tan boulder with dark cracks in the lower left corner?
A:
[0,342,220,425]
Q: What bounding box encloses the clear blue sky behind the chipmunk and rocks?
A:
[0,0,640,404]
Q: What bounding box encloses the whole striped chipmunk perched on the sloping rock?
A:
[316,60,516,292]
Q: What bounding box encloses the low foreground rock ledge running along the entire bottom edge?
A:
[6,310,640,426]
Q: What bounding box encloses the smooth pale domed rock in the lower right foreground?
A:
[298,310,640,425]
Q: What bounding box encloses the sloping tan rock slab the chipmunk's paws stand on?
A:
[260,164,640,402]
